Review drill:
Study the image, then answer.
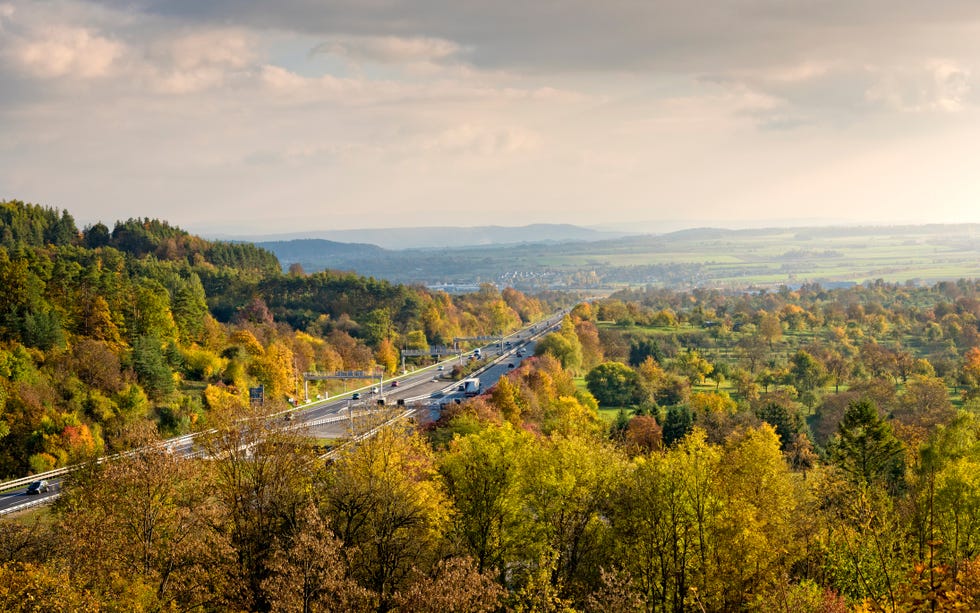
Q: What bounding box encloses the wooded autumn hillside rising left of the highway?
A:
[0,201,550,477]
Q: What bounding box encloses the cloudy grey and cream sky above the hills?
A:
[0,0,980,235]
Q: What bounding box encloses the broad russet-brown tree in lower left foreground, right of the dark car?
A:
[58,434,233,609]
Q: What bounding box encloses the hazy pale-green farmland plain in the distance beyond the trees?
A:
[264,224,980,290]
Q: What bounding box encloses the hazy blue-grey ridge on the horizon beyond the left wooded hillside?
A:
[238,224,627,249]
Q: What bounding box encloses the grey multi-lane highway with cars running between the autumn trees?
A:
[0,310,567,515]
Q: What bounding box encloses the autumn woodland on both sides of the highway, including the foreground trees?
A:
[0,198,980,613]
